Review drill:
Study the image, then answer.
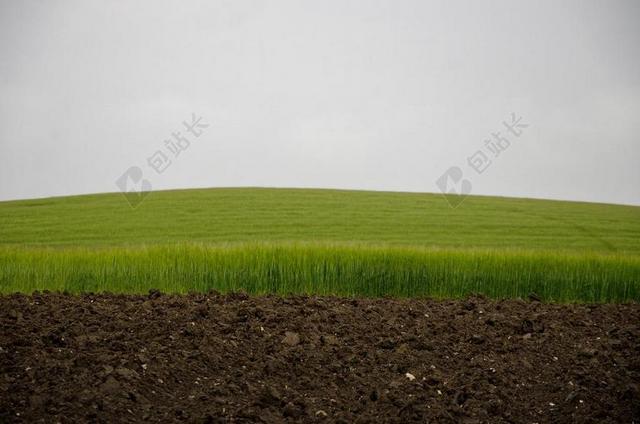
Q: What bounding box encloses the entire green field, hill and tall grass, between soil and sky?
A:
[0,188,640,302]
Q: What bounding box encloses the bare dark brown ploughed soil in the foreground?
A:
[0,293,640,423]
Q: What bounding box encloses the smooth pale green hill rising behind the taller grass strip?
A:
[0,188,640,254]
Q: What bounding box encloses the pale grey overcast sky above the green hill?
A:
[0,0,640,205]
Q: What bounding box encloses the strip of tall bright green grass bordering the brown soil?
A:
[0,244,640,302]
